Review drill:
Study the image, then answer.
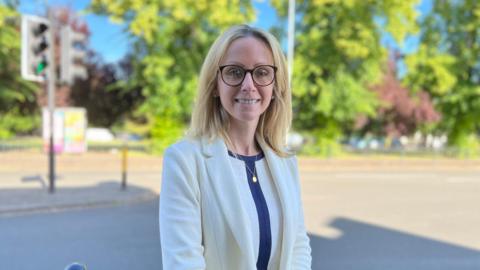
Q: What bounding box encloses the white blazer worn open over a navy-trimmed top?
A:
[159,139,312,270]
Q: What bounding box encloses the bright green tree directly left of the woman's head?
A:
[90,0,253,150]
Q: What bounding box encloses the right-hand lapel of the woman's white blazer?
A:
[260,141,295,269]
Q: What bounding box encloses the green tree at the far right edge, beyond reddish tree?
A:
[405,0,480,153]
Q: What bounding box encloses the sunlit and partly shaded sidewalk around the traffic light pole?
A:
[0,152,162,216]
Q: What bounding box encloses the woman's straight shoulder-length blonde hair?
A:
[187,25,292,156]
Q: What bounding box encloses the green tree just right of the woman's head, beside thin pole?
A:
[273,0,418,154]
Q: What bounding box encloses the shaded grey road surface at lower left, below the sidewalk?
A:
[0,200,161,270]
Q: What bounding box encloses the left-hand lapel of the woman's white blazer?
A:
[202,139,255,265]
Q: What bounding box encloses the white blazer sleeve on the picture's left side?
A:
[159,145,206,269]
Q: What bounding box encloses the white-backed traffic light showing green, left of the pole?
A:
[21,15,52,82]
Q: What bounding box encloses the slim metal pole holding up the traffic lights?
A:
[45,9,55,193]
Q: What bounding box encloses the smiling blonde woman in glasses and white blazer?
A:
[160,25,311,270]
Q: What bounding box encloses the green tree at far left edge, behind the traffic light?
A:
[0,3,40,139]
